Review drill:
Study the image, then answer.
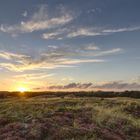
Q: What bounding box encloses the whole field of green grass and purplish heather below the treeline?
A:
[0,93,140,140]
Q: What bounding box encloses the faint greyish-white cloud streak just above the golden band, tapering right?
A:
[44,43,123,57]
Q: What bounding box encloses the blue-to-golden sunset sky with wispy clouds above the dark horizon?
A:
[0,0,140,91]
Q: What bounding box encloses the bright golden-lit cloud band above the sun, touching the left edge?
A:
[0,50,105,71]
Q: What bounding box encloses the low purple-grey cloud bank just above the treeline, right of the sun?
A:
[47,82,140,91]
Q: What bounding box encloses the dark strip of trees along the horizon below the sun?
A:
[0,91,140,99]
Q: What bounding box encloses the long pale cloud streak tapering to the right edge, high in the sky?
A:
[42,26,140,40]
